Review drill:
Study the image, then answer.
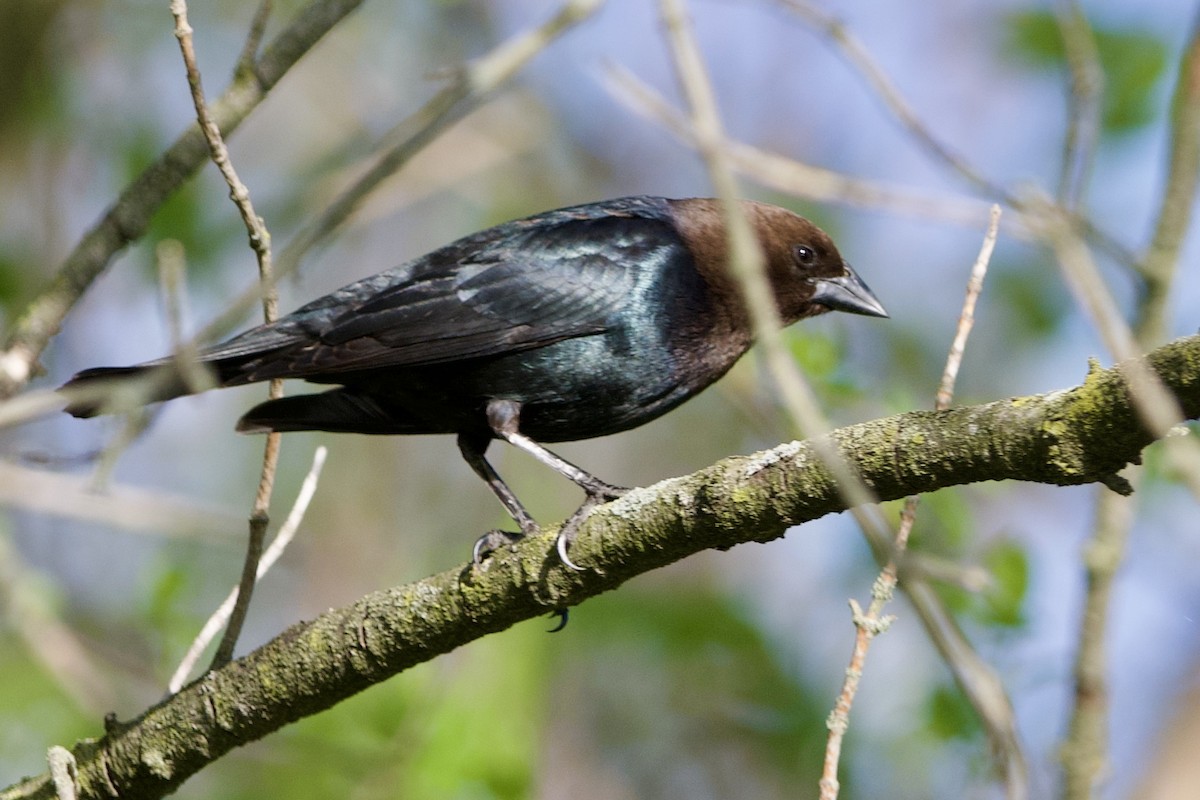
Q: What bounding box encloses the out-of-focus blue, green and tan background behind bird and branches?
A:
[0,0,1200,799]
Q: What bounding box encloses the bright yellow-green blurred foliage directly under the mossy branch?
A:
[220,620,549,800]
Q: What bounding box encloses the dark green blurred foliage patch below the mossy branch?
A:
[556,584,853,798]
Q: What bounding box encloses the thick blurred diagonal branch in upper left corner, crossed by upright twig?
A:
[0,0,362,398]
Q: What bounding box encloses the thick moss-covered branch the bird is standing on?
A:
[0,336,1200,800]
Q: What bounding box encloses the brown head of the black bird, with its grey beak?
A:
[672,198,888,325]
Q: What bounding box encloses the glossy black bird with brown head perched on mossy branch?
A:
[60,196,888,570]
